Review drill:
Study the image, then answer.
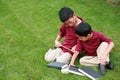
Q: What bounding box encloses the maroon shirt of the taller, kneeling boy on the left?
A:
[59,18,83,54]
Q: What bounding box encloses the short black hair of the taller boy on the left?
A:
[59,7,74,22]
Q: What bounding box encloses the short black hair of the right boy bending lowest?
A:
[75,22,92,37]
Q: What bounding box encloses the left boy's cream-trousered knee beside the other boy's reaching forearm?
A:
[56,52,72,63]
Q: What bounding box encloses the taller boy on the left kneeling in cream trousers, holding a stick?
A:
[45,7,83,63]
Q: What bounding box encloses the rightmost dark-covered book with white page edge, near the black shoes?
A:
[78,67,102,80]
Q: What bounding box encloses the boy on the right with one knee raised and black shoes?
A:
[70,22,114,74]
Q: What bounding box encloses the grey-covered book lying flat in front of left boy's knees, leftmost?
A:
[47,62,68,69]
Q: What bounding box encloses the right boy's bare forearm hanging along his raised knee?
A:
[100,42,114,64]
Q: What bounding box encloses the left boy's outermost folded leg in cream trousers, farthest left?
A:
[44,48,63,62]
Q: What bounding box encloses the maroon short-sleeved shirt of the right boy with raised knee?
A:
[76,32,111,56]
